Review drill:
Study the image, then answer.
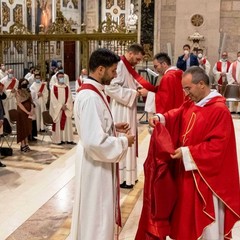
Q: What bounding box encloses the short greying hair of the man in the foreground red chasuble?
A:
[183,66,209,86]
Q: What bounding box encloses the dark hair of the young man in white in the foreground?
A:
[89,48,120,72]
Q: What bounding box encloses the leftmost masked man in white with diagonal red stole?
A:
[0,69,18,120]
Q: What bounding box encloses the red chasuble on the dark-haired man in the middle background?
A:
[155,69,184,113]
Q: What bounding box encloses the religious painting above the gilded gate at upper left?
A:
[35,0,52,33]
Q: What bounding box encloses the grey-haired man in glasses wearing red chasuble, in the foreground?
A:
[138,67,240,240]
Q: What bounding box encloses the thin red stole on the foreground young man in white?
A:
[78,83,122,227]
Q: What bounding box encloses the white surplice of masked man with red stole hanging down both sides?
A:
[49,84,73,143]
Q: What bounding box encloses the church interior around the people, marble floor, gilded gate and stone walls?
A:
[0,0,240,240]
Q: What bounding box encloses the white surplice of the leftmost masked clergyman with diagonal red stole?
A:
[0,75,18,120]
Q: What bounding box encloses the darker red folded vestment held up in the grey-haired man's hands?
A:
[135,123,177,240]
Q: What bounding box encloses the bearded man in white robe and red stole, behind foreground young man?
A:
[105,43,155,189]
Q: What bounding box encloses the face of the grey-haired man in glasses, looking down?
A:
[182,73,206,103]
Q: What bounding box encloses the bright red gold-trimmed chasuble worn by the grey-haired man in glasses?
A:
[164,96,240,240]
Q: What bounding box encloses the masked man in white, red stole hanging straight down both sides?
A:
[49,72,75,145]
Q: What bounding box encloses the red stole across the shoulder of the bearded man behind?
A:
[121,56,156,92]
